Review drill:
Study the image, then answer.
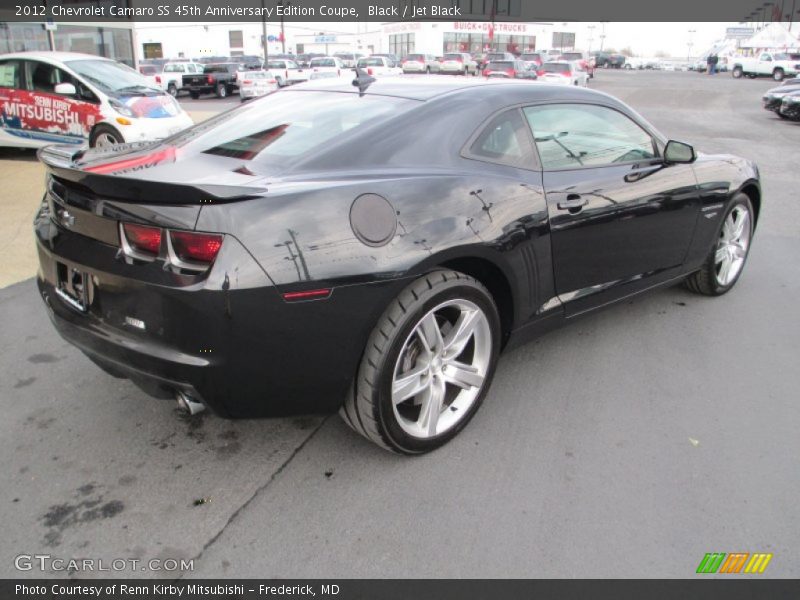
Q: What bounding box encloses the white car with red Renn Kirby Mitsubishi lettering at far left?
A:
[0,52,193,148]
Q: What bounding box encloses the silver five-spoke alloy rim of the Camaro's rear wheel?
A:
[391,299,492,439]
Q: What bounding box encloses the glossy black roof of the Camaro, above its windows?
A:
[284,74,611,104]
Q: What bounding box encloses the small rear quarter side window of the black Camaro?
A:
[466,108,536,169]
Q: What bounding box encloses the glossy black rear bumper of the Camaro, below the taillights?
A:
[35,213,406,418]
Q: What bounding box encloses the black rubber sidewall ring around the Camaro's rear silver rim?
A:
[374,279,500,454]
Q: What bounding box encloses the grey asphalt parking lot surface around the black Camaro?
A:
[0,70,800,578]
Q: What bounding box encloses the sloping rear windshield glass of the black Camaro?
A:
[162,92,416,167]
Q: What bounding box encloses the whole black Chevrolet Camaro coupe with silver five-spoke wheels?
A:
[35,77,761,454]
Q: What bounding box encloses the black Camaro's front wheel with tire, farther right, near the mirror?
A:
[686,193,755,296]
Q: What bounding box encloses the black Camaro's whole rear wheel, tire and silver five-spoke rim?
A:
[340,270,500,454]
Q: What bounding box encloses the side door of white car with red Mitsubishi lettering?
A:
[17,60,102,143]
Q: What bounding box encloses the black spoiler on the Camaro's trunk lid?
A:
[38,144,267,205]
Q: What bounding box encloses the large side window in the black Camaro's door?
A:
[523,104,656,169]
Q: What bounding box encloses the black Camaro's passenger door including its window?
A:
[523,103,700,315]
